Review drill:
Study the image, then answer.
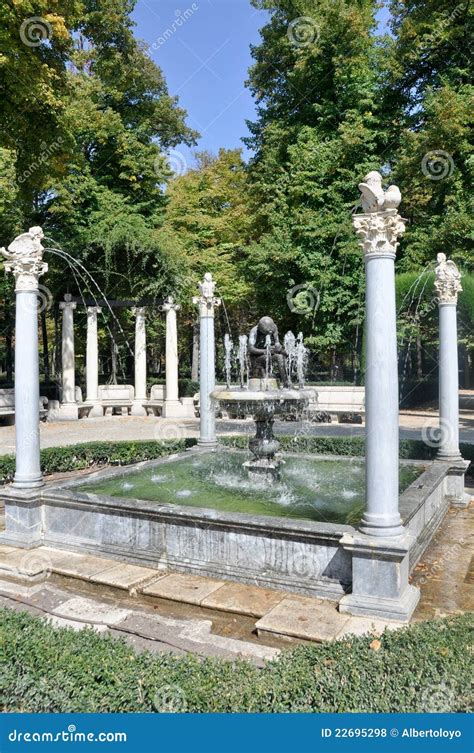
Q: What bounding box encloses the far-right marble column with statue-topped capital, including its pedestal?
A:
[434,253,469,506]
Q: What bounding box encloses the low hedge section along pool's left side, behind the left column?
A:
[0,439,196,484]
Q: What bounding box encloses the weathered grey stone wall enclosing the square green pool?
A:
[0,448,451,599]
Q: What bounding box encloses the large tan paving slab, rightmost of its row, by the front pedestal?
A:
[256,596,349,642]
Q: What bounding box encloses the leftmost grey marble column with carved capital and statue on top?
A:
[1,227,48,490]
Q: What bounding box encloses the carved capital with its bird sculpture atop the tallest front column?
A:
[352,170,405,259]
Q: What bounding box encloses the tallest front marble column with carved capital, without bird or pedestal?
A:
[353,192,405,536]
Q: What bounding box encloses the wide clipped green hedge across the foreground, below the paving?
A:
[0,609,473,713]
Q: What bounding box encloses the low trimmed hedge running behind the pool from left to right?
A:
[0,435,474,484]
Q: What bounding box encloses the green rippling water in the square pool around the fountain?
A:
[79,451,424,525]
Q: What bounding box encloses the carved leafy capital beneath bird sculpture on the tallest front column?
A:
[352,209,405,259]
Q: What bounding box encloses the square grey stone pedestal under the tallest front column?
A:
[339,532,420,622]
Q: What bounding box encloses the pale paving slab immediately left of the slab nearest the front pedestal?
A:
[201,582,285,617]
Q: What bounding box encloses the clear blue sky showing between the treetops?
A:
[133,0,387,172]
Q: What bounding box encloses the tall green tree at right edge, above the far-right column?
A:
[383,0,474,270]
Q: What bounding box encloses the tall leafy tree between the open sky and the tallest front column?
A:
[244,0,381,374]
